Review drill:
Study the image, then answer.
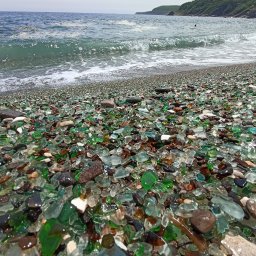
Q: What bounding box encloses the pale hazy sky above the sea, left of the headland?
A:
[0,0,188,14]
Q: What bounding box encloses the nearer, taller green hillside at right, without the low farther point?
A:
[178,0,256,18]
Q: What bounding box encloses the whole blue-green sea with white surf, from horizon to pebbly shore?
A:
[0,12,256,93]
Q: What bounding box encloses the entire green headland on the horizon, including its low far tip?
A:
[136,0,256,18]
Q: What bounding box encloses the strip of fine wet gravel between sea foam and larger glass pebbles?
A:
[0,62,256,98]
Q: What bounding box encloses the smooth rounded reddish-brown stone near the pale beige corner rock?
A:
[190,210,216,233]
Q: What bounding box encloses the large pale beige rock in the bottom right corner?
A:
[221,235,256,256]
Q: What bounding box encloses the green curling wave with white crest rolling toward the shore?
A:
[0,37,225,67]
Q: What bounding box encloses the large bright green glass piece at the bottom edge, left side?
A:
[39,219,63,256]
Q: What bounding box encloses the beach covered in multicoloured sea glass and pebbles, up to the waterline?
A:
[0,63,256,256]
